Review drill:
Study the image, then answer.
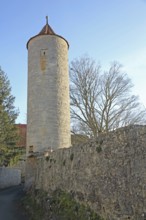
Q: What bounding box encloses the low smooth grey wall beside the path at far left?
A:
[0,167,21,189]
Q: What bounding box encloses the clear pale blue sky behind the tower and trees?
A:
[0,0,146,123]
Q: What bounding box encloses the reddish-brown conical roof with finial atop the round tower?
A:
[26,16,69,48]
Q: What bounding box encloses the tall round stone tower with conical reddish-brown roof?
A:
[27,17,71,154]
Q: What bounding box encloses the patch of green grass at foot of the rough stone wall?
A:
[23,190,103,220]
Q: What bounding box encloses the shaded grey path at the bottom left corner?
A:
[0,186,29,220]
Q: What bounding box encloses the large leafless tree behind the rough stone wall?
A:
[70,56,146,137]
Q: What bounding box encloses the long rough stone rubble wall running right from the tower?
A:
[30,125,146,220]
